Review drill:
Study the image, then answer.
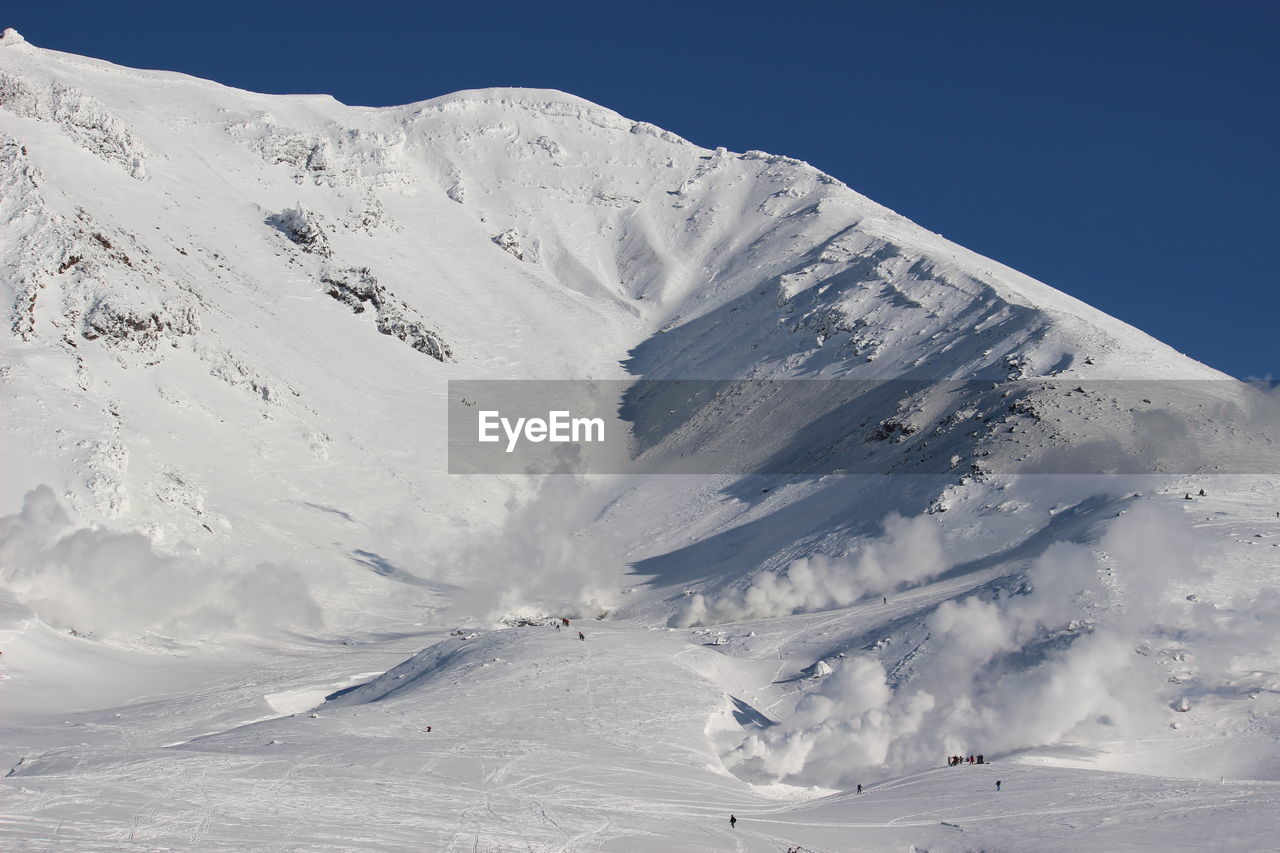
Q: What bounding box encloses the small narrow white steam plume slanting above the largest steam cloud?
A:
[671,514,947,628]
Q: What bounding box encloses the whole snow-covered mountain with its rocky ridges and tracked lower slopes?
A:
[0,29,1280,850]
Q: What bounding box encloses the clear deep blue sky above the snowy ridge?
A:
[0,0,1280,377]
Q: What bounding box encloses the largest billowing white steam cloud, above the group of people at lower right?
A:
[726,505,1277,786]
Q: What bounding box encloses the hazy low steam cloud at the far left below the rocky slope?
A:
[0,485,321,639]
